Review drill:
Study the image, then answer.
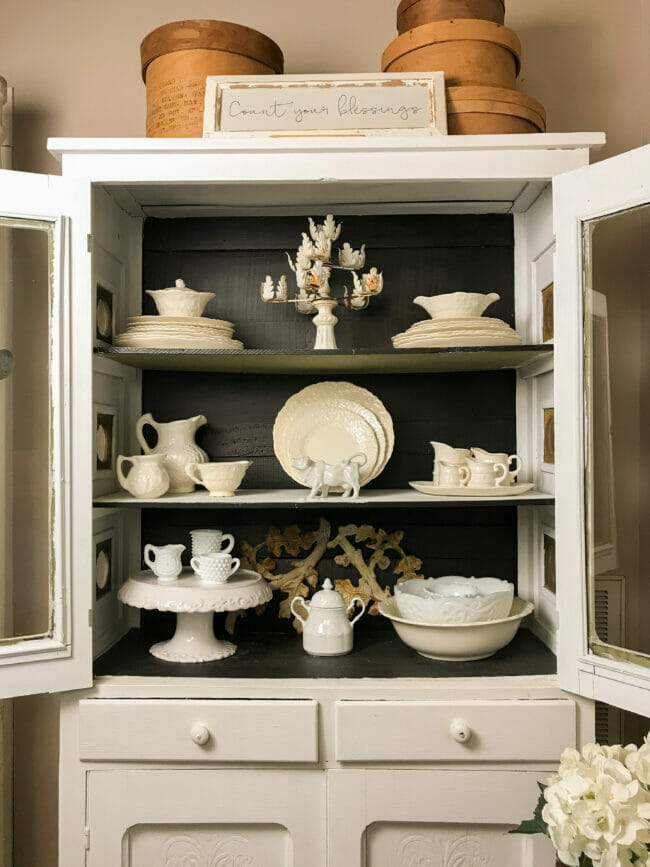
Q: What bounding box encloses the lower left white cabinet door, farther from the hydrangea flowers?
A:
[86,769,326,867]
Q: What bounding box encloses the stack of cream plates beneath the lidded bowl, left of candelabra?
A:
[113,316,244,349]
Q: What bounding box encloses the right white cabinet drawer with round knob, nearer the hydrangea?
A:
[336,699,576,762]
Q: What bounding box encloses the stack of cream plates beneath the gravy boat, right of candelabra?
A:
[393,316,521,349]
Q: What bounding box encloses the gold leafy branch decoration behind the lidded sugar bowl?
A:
[240,518,423,632]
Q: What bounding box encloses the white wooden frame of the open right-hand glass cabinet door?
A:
[553,146,650,716]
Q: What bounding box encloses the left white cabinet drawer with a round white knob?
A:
[79,699,318,762]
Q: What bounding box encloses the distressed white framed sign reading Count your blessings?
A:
[203,72,447,138]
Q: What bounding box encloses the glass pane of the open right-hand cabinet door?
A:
[583,205,650,666]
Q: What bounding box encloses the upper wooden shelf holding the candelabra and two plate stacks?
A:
[95,345,553,374]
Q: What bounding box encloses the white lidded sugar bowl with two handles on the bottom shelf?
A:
[291,578,366,656]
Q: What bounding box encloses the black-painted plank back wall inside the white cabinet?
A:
[92,214,554,676]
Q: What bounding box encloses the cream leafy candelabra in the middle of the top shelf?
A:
[260,214,384,349]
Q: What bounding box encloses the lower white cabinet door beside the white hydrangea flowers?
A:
[328,770,555,867]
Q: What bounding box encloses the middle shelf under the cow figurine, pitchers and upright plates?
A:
[93,488,554,509]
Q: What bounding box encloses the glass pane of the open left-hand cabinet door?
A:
[0,218,54,644]
